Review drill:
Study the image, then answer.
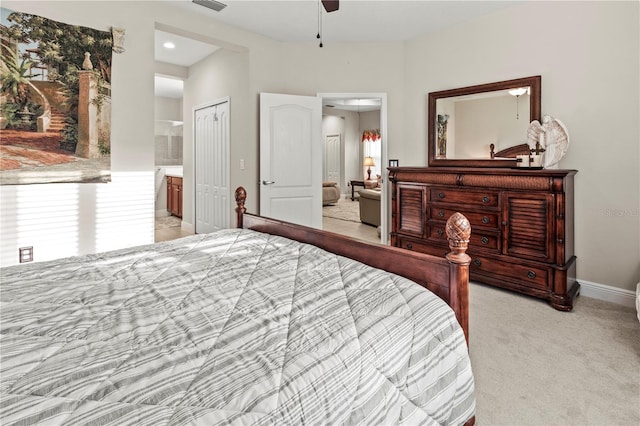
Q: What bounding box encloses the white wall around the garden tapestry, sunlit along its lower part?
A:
[0,1,154,266]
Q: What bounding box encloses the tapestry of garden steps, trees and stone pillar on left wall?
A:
[0,8,113,185]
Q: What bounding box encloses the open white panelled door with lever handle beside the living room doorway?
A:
[260,93,322,229]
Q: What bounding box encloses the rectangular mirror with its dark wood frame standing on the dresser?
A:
[427,76,542,167]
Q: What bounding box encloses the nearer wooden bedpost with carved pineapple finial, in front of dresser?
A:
[446,213,471,345]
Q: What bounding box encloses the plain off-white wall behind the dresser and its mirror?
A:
[408,1,640,290]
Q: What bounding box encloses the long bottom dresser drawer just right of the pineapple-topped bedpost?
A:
[469,255,552,290]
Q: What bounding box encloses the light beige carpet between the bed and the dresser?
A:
[469,283,640,426]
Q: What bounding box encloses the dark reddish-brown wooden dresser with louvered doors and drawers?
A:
[389,167,580,311]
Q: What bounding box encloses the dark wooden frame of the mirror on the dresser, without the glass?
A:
[427,75,542,168]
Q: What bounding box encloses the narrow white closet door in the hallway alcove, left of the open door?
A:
[194,100,230,234]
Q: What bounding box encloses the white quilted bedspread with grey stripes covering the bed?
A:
[0,229,475,426]
